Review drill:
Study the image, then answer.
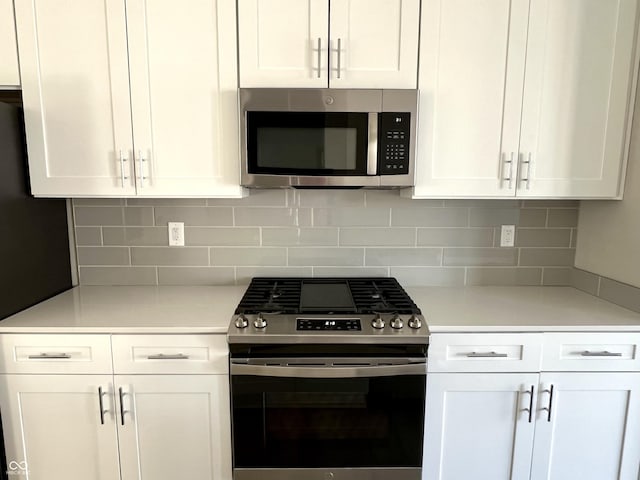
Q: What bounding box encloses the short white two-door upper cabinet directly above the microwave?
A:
[238,0,420,88]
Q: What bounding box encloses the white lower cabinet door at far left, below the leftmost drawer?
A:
[0,375,120,480]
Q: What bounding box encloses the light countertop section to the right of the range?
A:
[405,287,640,333]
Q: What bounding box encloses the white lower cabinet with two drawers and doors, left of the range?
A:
[0,335,231,480]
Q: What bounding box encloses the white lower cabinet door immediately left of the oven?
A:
[115,375,231,480]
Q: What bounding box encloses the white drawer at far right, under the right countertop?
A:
[542,333,640,372]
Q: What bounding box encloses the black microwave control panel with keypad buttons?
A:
[378,112,411,175]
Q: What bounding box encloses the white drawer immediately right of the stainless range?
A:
[429,333,542,372]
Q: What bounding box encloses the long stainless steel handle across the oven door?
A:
[231,363,427,378]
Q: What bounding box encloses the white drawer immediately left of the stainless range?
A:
[112,334,229,374]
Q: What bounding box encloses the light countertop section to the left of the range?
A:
[0,286,246,333]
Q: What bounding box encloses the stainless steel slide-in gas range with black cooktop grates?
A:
[228,277,429,480]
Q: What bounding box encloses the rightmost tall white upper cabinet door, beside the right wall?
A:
[518,0,638,198]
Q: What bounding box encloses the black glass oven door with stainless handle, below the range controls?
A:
[231,358,426,480]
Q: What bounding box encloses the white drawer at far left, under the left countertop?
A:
[0,334,111,374]
